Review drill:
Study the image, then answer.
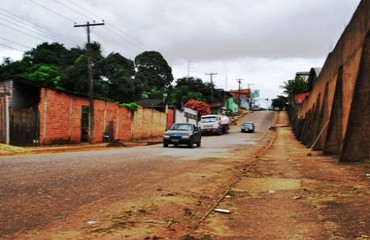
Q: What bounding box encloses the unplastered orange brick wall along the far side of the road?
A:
[38,88,167,144]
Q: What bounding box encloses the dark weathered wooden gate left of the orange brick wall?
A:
[9,108,40,146]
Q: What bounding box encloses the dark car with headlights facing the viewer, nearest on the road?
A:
[163,123,202,148]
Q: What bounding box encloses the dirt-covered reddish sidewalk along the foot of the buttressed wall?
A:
[197,112,370,240]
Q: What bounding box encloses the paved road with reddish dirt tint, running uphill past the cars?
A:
[0,112,274,237]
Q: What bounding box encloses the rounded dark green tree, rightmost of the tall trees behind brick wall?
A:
[134,51,173,98]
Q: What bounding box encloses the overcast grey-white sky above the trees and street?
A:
[0,0,360,105]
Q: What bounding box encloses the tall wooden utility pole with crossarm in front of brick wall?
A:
[74,21,104,143]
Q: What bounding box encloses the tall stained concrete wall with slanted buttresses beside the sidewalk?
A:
[291,0,370,161]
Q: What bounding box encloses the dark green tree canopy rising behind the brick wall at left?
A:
[0,42,173,103]
